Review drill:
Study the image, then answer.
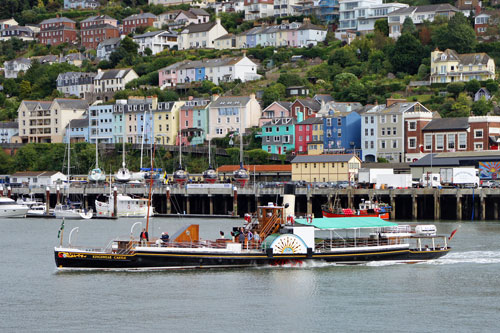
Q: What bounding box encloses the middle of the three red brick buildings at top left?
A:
[80,15,120,49]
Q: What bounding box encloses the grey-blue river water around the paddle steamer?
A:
[0,218,500,332]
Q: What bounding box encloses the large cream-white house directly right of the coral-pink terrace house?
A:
[207,94,262,140]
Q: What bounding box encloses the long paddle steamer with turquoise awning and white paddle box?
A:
[54,201,451,269]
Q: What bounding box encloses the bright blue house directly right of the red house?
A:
[323,108,364,158]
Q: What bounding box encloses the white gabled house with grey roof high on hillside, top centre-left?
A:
[178,18,227,50]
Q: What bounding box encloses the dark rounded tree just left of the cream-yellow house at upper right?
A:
[391,34,424,74]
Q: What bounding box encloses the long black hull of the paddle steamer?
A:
[55,249,449,269]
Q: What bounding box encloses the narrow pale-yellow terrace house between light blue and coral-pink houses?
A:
[154,101,186,145]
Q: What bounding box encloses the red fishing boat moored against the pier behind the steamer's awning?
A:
[321,196,392,220]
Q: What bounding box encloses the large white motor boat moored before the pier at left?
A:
[95,194,154,217]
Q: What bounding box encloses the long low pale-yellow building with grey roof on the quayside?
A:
[292,154,361,182]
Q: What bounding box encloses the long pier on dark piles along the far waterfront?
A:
[3,184,500,220]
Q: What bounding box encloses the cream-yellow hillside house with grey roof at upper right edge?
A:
[431,49,495,83]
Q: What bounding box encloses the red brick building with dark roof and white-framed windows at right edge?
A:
[422,116,500,153]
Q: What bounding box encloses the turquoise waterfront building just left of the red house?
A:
[260,117,296,155]
